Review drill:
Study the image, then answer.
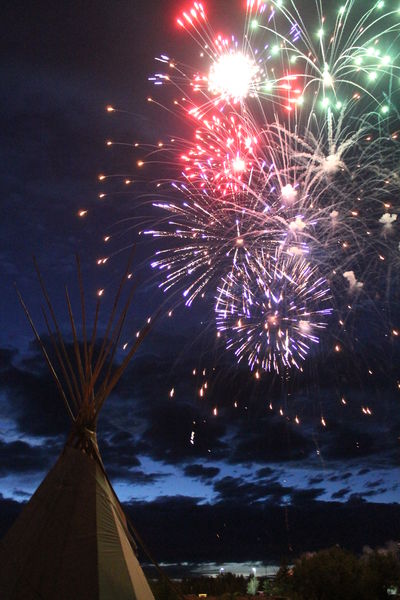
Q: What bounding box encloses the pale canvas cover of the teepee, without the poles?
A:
[0,445,154,600]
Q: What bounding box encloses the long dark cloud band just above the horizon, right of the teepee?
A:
[126,497,400,563]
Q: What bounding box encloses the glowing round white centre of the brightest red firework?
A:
[208,52,258,102]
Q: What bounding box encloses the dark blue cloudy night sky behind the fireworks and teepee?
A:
[0,0,400,566]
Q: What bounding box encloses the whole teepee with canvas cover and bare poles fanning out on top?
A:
[0,260,154,600]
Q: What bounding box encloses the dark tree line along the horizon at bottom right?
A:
[152,545,400,600]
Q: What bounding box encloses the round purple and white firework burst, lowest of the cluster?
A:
[215,247,332,372]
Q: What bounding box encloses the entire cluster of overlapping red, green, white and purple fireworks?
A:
[103,0,400,371]
